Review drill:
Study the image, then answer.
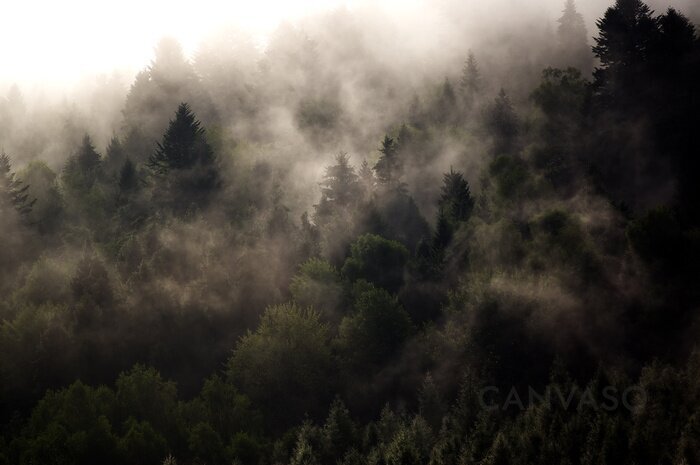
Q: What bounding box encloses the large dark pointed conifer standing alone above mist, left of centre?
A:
[148,103,221,214]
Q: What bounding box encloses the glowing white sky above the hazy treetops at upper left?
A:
[0,0,386,85]
